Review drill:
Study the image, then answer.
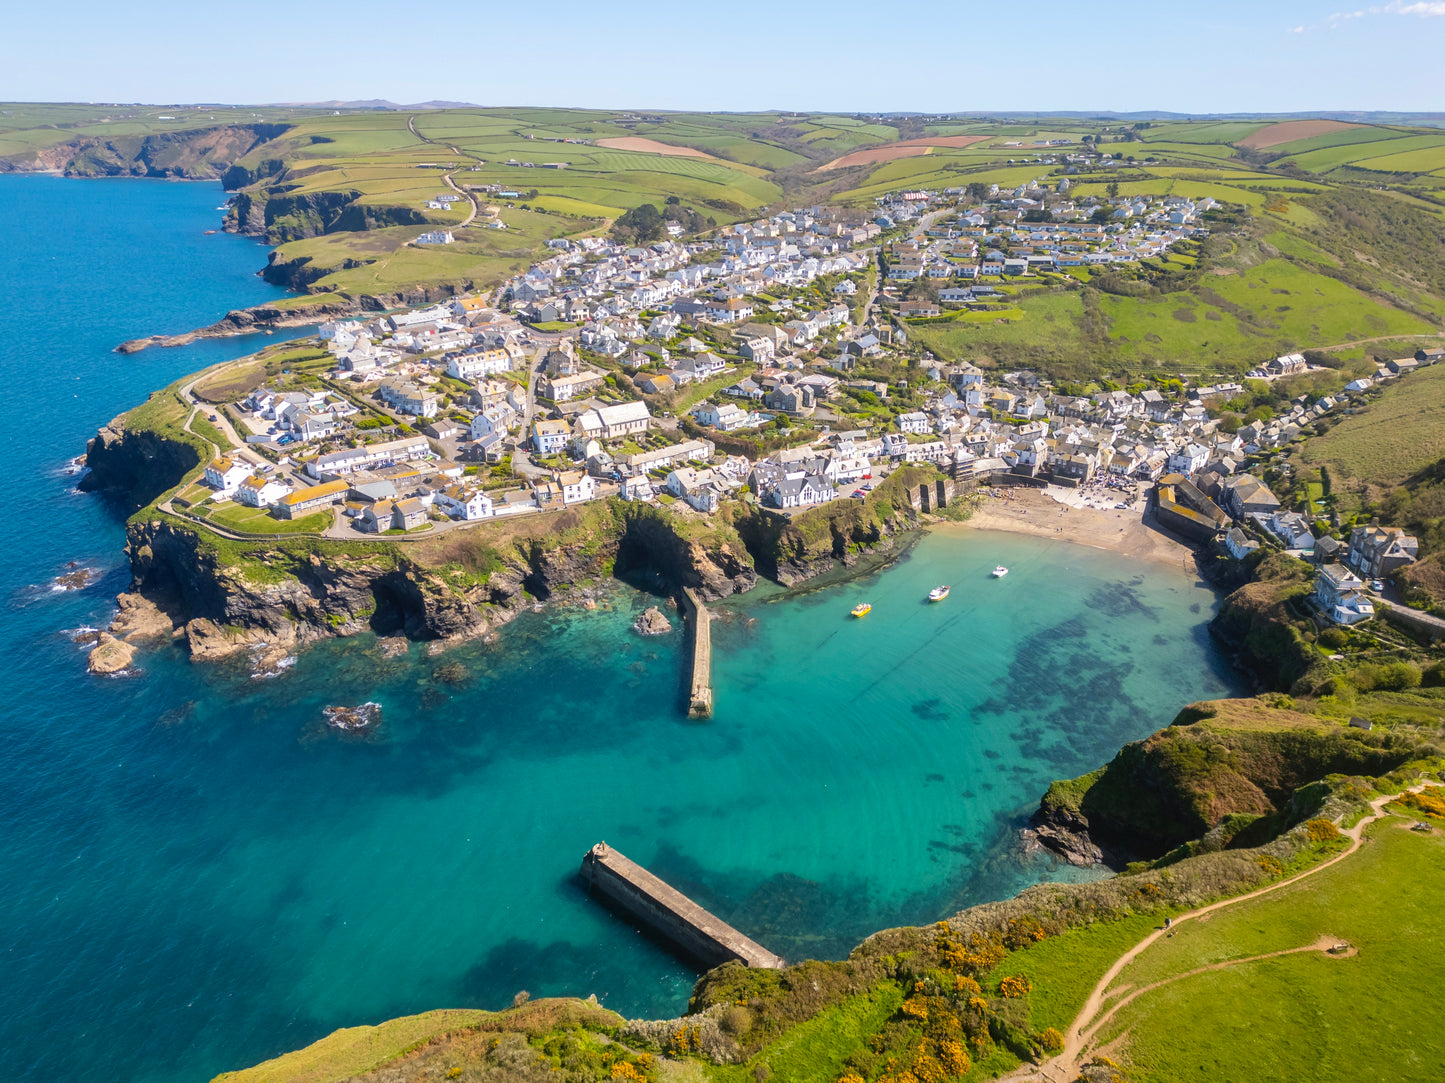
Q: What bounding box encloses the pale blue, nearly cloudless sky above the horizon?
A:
[8,0,1445,113]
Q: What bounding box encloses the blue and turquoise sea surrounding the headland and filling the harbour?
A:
[0,176,1234,1083]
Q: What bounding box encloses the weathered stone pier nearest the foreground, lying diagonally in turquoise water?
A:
[582,843,785,970]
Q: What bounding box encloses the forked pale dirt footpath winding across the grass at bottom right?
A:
[1003,782,1439,1083]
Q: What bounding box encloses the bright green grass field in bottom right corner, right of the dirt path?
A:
[1101,818,1445,1083]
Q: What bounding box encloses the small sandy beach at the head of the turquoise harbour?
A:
[935,486,1198,575]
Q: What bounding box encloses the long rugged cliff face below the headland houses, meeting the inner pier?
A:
[126,508,757,659]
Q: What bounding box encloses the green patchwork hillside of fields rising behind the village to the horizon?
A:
[11,106,1445,367]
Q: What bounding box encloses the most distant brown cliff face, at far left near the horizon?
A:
[0,124,289,181]
